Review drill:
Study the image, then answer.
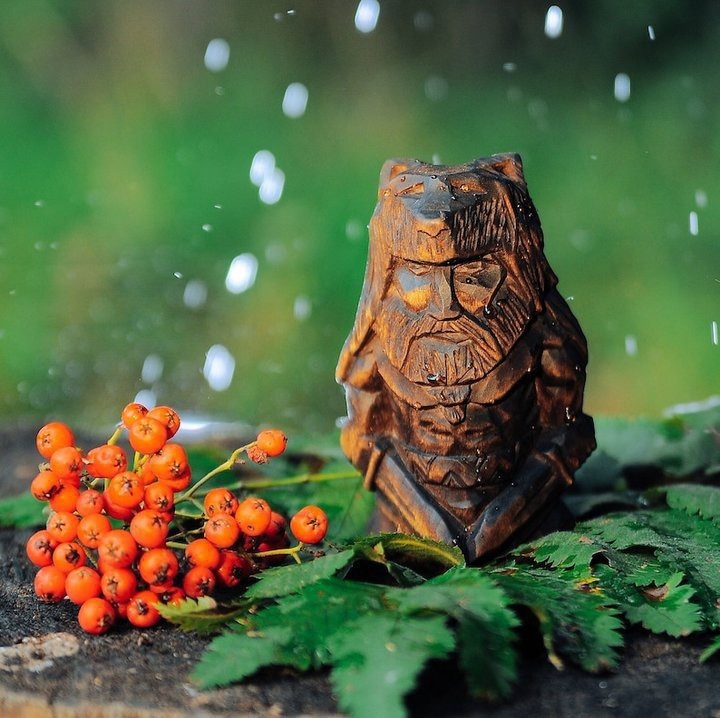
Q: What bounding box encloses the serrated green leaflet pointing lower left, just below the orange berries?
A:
[191,625,294,688]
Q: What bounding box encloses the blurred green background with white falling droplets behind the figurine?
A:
[0,0,720,433]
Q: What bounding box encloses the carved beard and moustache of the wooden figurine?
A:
[375,287,534,386]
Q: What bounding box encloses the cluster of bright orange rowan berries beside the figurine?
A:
[26,403,327,634]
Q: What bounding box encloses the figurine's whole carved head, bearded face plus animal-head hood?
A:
[338,155,556,394]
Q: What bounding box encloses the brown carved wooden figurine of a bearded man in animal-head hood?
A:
[337,154,595,562]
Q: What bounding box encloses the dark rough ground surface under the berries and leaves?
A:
[0,431,720,718]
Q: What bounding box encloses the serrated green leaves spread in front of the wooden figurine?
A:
[166,486,720,717]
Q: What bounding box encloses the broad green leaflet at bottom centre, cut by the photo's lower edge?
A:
[329,613,455,718]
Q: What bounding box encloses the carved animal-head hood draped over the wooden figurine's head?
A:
[337,154,557,382]
